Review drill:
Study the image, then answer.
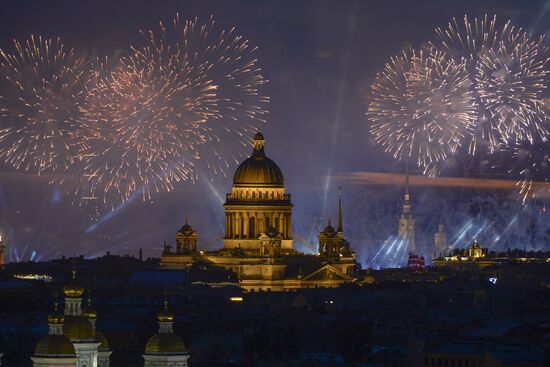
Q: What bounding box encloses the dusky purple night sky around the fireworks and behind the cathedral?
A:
[0,0,550,266]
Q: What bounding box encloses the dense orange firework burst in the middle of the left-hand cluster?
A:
[82,47,211,203]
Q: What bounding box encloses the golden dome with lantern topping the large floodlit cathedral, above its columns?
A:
[233,132,284,186]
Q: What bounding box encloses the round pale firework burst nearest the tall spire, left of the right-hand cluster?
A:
[367,48,475,174]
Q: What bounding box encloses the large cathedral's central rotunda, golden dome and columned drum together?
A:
[223,131,292,255]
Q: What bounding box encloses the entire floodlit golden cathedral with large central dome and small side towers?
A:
[161,132,357,291]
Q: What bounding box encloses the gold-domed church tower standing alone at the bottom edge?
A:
[143,299,189,367]
